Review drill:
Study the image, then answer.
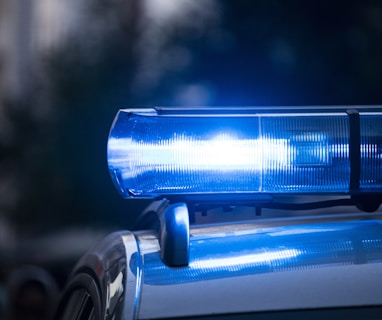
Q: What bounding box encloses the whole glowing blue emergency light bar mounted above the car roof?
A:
[108,108,382,198]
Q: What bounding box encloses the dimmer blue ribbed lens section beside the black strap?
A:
[261,113,350,192]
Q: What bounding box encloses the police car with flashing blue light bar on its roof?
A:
[56,106,382,320]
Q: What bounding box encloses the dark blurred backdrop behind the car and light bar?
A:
[0,0,382,318]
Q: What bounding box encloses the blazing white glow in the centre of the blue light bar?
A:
[109,134,290,171]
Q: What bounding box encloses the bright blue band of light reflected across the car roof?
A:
[130,220,382,285]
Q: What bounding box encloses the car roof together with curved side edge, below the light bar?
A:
[60,214,382,319]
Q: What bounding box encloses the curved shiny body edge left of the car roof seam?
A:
[62,231,139,319]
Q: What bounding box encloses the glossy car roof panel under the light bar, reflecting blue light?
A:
[135,214,382,319]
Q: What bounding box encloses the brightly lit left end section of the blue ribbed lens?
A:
[108,112,261,195]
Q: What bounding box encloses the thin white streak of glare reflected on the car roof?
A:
[190,249,301,270]
